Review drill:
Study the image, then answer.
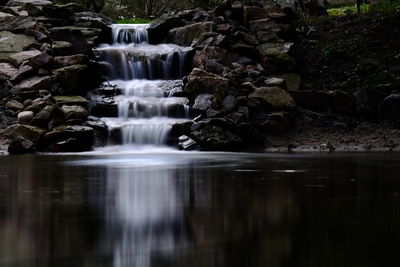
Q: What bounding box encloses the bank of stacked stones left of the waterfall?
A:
[0,0,111,154]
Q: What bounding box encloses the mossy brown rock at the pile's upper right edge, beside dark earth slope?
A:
[257,43,296,72]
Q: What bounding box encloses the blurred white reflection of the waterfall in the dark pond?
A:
[107,159,185,267]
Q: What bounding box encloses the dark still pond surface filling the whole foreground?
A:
[0,152,400,267]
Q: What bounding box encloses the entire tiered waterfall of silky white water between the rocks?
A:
[96,24,191,146]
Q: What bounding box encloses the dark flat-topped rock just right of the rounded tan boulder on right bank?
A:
[290,90,332,111]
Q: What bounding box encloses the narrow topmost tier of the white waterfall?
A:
[112,24,149,44]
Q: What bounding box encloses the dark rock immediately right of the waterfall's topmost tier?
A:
[147,15,183,44]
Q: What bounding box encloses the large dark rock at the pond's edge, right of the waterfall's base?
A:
[191,125,243,151]
